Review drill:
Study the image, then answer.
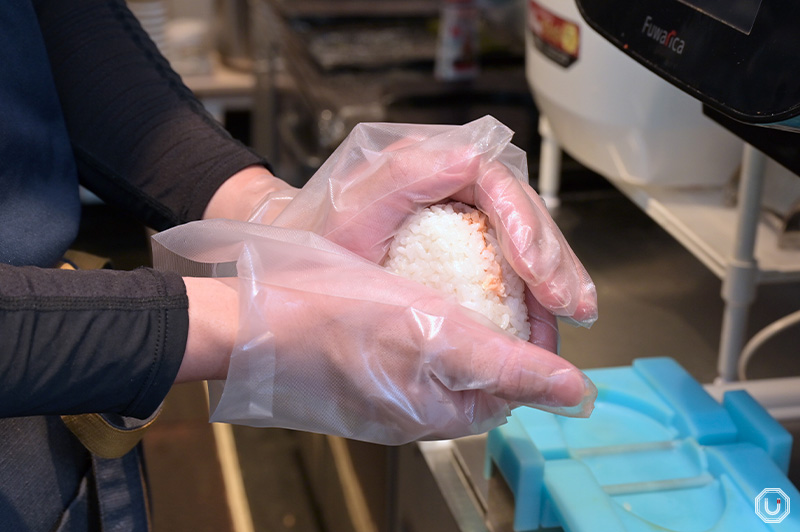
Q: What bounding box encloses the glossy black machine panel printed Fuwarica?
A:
[577,0,800,124]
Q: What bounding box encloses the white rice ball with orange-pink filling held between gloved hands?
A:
[384,203,530,340]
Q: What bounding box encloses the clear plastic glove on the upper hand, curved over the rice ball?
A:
[250,116,597,327]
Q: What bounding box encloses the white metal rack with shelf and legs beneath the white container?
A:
[539,117,800,419]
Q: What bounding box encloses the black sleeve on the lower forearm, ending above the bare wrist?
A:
[0,264,189,418]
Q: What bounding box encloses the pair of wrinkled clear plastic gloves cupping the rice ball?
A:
[154,117,597,445]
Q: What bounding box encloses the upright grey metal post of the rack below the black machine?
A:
[717,144,767,383]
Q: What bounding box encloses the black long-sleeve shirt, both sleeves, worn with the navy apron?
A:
[0,0,263,417]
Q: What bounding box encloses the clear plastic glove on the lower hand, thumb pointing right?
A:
[153,220,596,444]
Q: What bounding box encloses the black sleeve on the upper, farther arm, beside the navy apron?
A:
[35,0,266,230]
